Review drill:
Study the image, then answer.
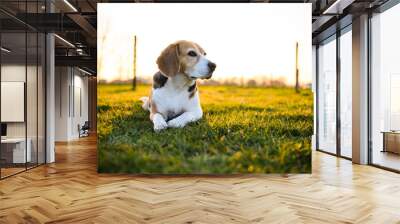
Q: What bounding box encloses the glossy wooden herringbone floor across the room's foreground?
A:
[0,137,400,224]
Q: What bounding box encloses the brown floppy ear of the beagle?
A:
[157,44,180,77]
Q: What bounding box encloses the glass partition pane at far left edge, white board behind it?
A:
[1,32,27,177]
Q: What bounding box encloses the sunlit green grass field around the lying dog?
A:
[97,84,313,174]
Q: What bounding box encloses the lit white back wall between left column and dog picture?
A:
[55,67,88,141]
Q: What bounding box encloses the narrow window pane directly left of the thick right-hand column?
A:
[340,31,352,158]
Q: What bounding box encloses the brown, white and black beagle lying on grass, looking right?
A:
[140,40,216,132]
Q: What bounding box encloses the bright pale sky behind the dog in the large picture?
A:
[97,3,311,84]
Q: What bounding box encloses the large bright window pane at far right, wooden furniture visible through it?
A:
[371,5,400,170]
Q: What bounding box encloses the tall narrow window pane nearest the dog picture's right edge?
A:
[318,39,336,156]
